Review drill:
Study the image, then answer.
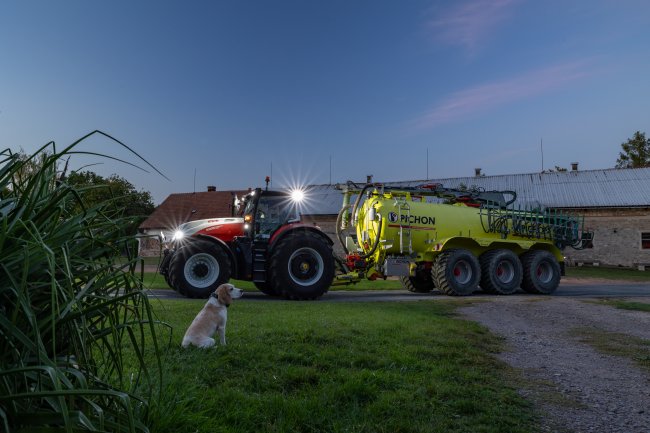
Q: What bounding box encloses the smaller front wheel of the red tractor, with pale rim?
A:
[169,241,231,298]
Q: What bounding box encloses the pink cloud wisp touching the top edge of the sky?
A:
[429,0,519,53]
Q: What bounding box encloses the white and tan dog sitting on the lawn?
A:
[181,284,244,348]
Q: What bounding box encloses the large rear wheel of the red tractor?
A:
[269,232,334,300]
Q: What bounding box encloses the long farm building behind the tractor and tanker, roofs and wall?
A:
[140,165,650,267]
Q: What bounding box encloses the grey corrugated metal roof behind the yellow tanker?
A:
[304,168,650,215]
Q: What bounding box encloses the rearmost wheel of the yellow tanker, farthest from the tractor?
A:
[521,250,560,295]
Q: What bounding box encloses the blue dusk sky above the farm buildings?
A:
[0,0,650,203]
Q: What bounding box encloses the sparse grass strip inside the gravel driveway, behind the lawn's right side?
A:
[572,328,650,371]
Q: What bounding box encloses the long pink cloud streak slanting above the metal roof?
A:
[412,62,587,129]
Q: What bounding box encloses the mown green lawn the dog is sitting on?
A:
[139,301,536,433]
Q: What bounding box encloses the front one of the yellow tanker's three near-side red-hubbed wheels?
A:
[431,249,481,296]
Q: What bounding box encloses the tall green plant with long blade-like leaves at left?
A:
[0,131,165,432]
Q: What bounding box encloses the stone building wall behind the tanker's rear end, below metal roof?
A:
[564,208,650,267]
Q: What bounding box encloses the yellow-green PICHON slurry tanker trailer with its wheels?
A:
[339,184,584,295]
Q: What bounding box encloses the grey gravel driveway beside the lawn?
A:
[459,296,650,433]
